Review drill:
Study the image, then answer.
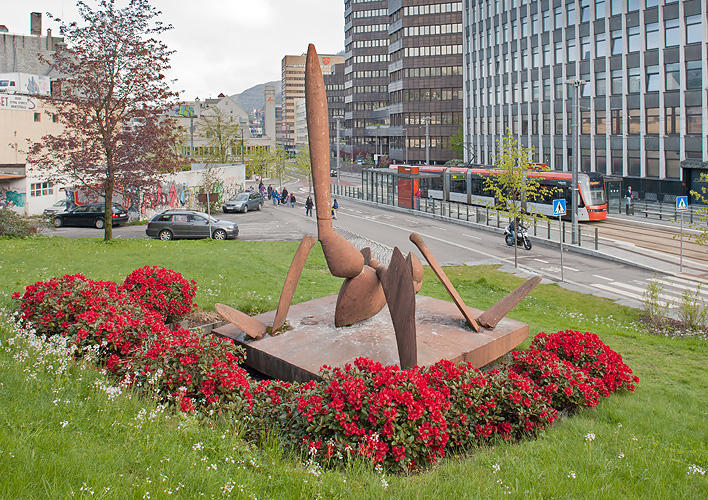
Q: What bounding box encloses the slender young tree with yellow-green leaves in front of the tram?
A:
[484,131,553,267]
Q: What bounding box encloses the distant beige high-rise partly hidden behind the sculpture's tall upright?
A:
[281,54,344,154]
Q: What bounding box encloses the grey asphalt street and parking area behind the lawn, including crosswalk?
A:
[49,185,708,307]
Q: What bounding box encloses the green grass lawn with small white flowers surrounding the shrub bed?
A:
[0,238,708,499]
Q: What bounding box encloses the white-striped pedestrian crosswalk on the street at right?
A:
[590,276,708,308]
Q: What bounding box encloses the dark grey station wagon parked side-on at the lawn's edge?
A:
[145,210,238,241]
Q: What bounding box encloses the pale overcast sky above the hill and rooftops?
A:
[0,0,344,99]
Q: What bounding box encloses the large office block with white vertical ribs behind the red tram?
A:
[463,0,708,197]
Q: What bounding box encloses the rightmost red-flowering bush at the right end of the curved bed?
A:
[531,330,639,393]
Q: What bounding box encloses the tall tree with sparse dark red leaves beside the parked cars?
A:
[28,0,178,241]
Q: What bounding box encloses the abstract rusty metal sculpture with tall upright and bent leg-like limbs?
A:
[216,44,541,368]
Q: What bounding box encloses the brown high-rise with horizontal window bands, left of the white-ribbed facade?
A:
[344,0,462,163]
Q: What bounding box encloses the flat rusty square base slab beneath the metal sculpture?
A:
[213,295,529,382]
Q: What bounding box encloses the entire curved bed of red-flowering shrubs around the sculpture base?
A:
[14,274,638,470]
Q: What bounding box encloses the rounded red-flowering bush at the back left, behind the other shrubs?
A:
[122,266,197,323]
